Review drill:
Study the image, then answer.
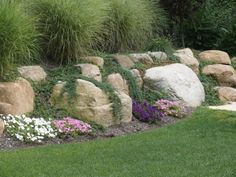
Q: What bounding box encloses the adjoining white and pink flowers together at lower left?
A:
[0,115,92,143]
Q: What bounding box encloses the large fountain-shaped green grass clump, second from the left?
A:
[29,0,107,64]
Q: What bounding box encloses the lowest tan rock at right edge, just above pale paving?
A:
[218,87,236,102]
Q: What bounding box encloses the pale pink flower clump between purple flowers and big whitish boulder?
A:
[154,99,187,118]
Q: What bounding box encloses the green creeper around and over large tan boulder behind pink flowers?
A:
[30,66,122,119]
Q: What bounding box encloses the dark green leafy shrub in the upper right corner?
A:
[185,0,236,52]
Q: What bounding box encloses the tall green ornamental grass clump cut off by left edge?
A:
[0,0,39,80]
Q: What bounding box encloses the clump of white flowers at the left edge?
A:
[0,115,57,143]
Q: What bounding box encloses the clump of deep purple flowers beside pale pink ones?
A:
[133,100,164,122]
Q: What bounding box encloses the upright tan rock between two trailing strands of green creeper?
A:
[107,73,129,95]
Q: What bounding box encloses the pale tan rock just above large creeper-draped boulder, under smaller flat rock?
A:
[75,64,102,82]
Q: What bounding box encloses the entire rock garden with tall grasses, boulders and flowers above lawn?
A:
[0,0,236,150]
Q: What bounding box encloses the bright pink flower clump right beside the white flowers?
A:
[53,117,92,135]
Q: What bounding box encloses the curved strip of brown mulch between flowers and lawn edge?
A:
[0,117,180,151]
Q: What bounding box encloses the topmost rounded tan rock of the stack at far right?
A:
[199,50,231,65]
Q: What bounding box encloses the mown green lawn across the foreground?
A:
[0,108,236,177]
